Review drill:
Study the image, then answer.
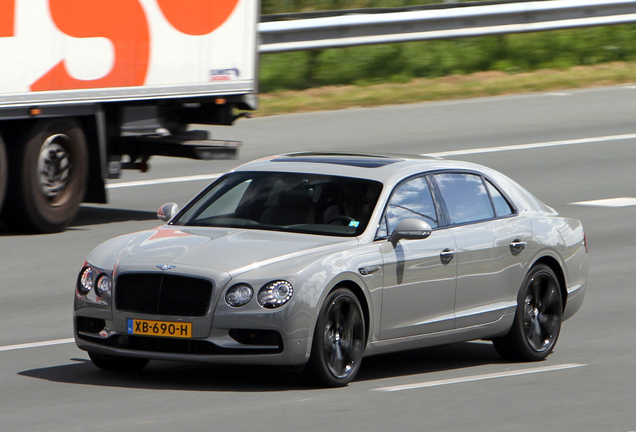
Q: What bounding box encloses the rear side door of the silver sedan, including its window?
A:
[433,173,532,328]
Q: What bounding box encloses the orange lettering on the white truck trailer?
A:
[25,0,238,91]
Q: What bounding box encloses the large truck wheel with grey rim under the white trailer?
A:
[2,118,88,233]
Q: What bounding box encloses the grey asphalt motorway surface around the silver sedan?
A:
[0,86,636,432]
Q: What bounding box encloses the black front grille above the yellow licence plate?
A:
[115,273,212,316]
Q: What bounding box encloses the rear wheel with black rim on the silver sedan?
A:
[493,264,563,361]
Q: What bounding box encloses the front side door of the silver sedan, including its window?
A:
[380,177,456,339]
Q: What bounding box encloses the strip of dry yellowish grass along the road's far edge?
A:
[255,62,636,116]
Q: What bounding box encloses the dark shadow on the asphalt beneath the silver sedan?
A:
[18,343,505,392]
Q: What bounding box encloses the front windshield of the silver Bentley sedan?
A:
[174,172,382,236]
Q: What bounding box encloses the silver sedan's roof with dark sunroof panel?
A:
[235,152,490,184]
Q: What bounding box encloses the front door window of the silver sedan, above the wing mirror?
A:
[378,177,439,236]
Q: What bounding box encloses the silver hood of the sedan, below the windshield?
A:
[88,225,358,277]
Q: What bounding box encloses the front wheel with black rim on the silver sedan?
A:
[303,288,366,387]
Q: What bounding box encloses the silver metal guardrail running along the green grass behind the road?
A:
[258,0,636,54]
